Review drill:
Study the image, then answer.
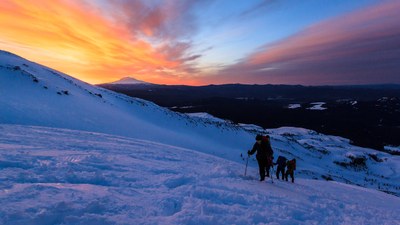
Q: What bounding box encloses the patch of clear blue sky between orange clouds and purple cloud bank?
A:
[193,0,377,70]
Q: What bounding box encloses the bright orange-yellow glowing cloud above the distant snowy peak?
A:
[0,0,197,83]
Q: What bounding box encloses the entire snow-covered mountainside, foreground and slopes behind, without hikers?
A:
[0,52,400,224]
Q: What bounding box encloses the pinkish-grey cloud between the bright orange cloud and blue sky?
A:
[103,0,210,83]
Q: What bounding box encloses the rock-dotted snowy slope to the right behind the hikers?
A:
[268,127,400,196]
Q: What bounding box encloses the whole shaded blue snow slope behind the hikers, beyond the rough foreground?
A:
[0,51,400,199]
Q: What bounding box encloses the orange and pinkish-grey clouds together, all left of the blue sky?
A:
[0,0,201,83]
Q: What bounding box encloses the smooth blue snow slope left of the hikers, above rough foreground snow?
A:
[0,52,253,159]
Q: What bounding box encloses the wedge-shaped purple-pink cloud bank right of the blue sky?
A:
[207,1,400,85]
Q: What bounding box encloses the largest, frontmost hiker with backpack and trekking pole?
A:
[247,135,273,181]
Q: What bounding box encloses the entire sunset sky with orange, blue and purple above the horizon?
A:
[0,0,400,85]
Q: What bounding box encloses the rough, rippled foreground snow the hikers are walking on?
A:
[0,125,400,225]
